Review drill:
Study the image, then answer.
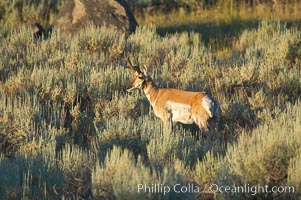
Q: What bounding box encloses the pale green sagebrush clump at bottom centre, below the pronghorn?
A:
[92,147,191,199]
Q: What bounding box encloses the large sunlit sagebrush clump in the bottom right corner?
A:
[223,105,301,198]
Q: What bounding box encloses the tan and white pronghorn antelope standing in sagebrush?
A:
[127,59,221,135]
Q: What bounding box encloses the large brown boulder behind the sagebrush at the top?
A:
[54,0,137,34]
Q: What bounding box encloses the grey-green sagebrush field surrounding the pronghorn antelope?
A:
[0,0,301,199]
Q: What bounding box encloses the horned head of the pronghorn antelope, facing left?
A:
[127,59,150,92]
